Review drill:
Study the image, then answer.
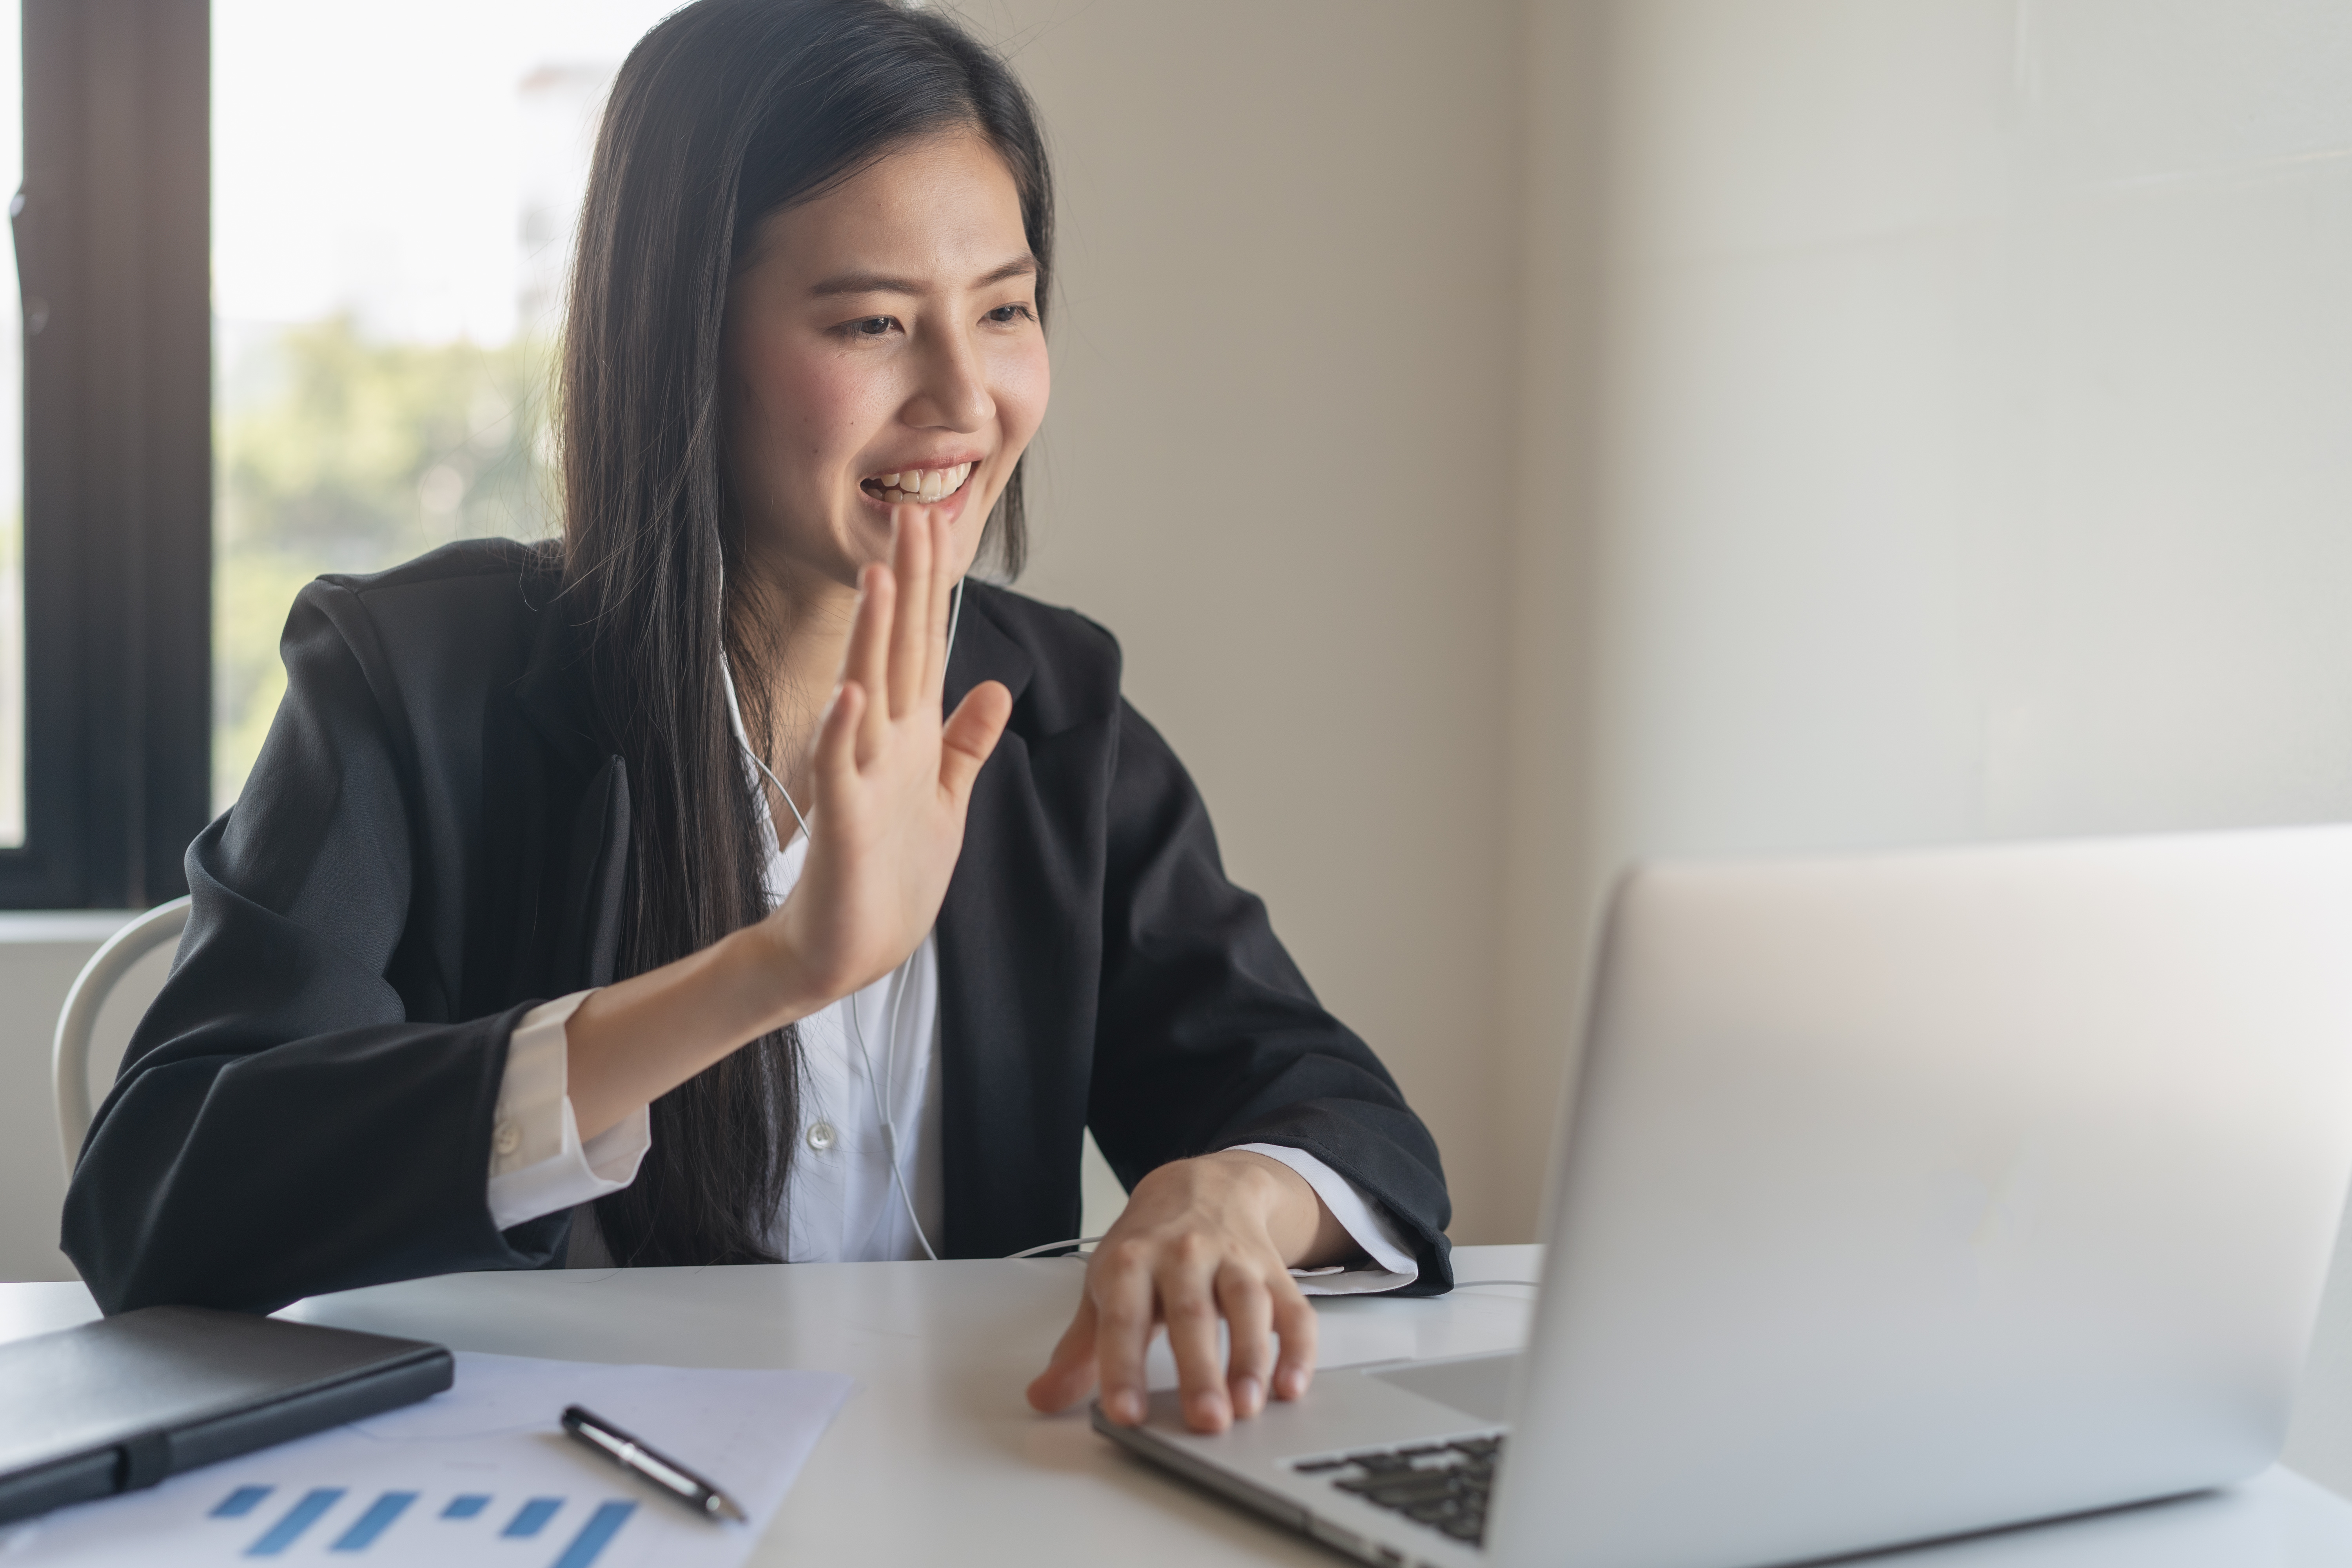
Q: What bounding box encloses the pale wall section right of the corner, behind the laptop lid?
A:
[1498,0,2352,1483]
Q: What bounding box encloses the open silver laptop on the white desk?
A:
[1094,828,2352,1568]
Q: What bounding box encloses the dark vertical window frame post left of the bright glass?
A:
[0,0,212,910]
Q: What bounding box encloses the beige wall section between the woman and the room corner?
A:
[957,0,1522,1241]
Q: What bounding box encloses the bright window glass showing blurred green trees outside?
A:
[212,0,670,808]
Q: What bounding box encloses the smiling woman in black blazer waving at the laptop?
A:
[66,0,1449,1429]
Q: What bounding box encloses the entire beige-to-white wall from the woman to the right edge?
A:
[988,0,2352,1239]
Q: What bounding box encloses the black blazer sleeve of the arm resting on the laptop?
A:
[1087,698,1454,1295]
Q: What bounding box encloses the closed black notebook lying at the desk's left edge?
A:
[0,1307,456,1521]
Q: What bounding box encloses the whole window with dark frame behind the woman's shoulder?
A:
[0,0,670,907]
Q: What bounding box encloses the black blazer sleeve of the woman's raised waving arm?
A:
[64,583,569,1312]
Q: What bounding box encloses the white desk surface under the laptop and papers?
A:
[0,1246,2352,1568]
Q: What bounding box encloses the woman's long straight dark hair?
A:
[560,0,1054,1265]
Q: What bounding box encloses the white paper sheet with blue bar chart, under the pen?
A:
[0,1349,851,1568]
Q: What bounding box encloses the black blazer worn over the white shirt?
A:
[64,541,1451,1312]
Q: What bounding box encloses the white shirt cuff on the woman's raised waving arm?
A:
[489,992,654,1229]
